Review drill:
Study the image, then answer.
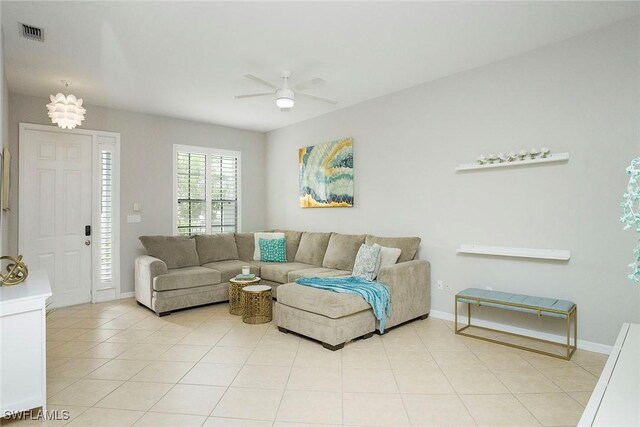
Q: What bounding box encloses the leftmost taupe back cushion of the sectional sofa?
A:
[140,236,200,268]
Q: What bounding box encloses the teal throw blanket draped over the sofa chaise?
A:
[296,276,391,333]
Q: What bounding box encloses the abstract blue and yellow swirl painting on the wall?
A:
[298,138,353,208]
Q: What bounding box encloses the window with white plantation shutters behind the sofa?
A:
[174,145,240,236]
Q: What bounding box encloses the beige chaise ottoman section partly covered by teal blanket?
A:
[274,283,376,351]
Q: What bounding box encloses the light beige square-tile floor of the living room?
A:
[0,300,606,427]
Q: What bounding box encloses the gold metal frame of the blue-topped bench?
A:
[454,295,578,360]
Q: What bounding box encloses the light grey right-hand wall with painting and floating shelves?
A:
[266,19,640,344]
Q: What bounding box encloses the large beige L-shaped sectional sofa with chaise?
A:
[135,230,431,349]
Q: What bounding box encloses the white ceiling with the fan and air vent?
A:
[2,1,640,131]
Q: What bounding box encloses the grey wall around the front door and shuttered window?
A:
[8,93,266,292]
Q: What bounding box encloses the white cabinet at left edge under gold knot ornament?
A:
[0,271,51,415]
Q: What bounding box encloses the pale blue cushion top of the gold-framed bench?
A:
[458,288,575,318]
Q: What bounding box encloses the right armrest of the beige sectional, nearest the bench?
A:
[377,260,431,327]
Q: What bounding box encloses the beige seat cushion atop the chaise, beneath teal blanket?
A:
[278,283,371,319]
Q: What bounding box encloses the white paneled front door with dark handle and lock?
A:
[19,129,94,307]
